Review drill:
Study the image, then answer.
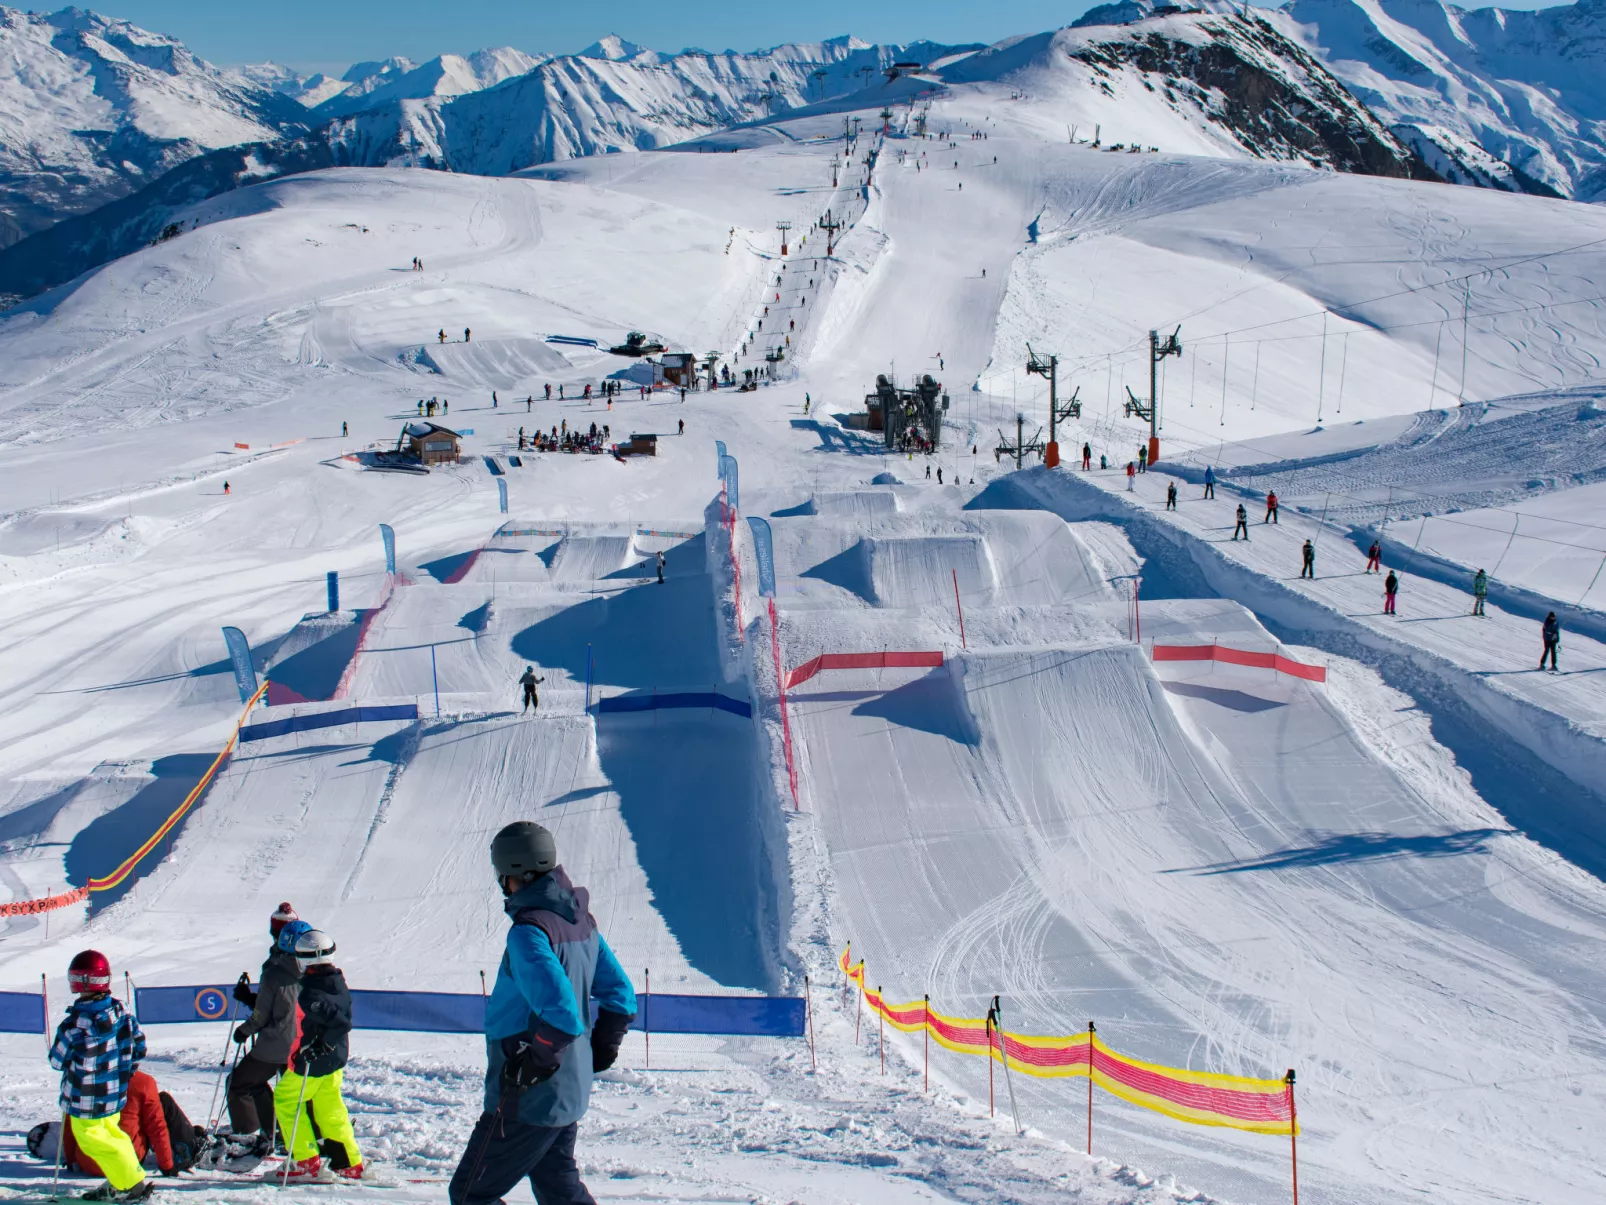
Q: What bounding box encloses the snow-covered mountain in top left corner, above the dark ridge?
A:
[0,8,307,246]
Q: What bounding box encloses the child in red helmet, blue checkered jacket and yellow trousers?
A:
[50,950,153,1202]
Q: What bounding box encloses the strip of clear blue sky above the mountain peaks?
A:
[93,0,1561,72]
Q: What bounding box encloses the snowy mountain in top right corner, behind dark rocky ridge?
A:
[1272,0,1606,201]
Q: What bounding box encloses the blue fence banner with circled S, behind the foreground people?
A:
[131,985,806,1038]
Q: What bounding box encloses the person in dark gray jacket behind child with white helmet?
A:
[222,901,312,1170]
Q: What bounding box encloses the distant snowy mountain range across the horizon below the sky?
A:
[0,0,1606,299]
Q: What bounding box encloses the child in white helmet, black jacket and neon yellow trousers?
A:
[273,929,363,1184]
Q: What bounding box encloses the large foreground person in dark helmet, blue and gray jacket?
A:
[446,819,636,1205]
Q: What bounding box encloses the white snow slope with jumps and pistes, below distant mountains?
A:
[0,61,1606,1205]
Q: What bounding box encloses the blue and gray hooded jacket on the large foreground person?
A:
[485,866,636,1126]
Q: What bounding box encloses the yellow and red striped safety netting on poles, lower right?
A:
[840,946,1299,1134]
